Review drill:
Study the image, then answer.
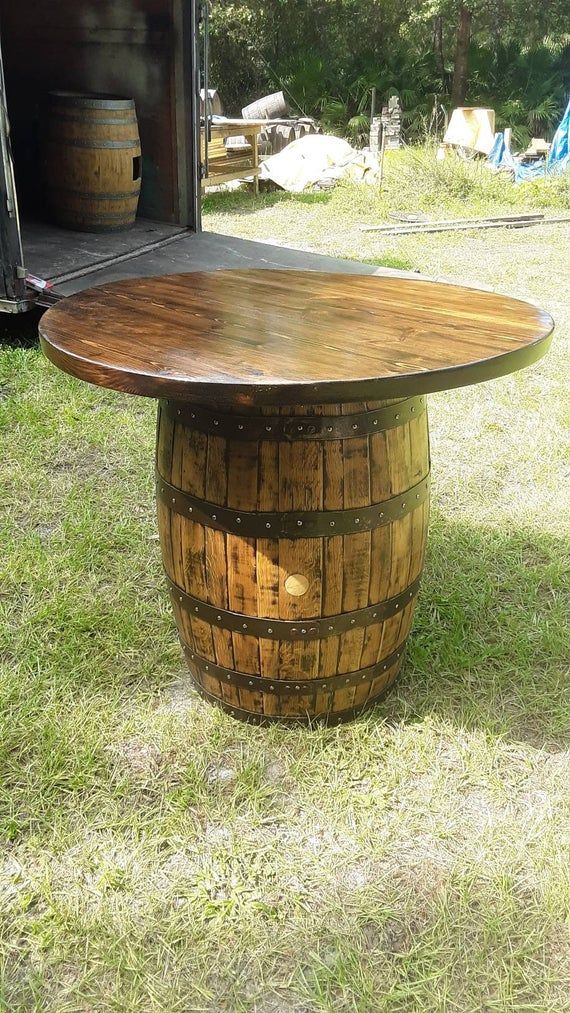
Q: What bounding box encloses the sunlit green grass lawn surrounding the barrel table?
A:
[0,151,570,1013]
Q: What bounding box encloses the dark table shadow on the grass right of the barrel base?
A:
[382,515,570,750]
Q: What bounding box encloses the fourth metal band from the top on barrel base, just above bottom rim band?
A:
[182,643,405,697]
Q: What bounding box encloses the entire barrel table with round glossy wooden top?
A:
[39,269,553,723]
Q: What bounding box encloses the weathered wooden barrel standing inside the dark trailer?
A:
[43,91,141,232]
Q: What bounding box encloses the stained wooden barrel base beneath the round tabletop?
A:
[157,396,429,723]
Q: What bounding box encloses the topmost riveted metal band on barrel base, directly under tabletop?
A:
[161,396,426,441]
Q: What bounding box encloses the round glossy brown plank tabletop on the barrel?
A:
[39,269,554,405]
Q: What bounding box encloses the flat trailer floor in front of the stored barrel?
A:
[21,218,187,281]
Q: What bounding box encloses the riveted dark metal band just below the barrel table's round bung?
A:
[166,575,420,640]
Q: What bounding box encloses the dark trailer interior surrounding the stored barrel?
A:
[0,0,199,293]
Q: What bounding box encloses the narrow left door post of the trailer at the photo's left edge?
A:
[0,40,30,313]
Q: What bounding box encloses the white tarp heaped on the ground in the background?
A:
[259,134,380,193]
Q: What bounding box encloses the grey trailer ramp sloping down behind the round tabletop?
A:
[46,226,417,296]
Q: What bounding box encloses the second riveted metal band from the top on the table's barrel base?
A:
[156,473,429,538]
